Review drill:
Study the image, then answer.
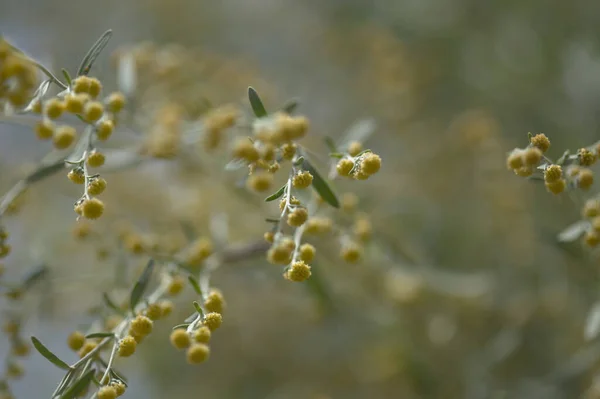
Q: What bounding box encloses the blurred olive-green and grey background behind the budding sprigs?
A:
[0,0,600,399]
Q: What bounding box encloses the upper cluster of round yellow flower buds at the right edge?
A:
[506,133,600,194]
